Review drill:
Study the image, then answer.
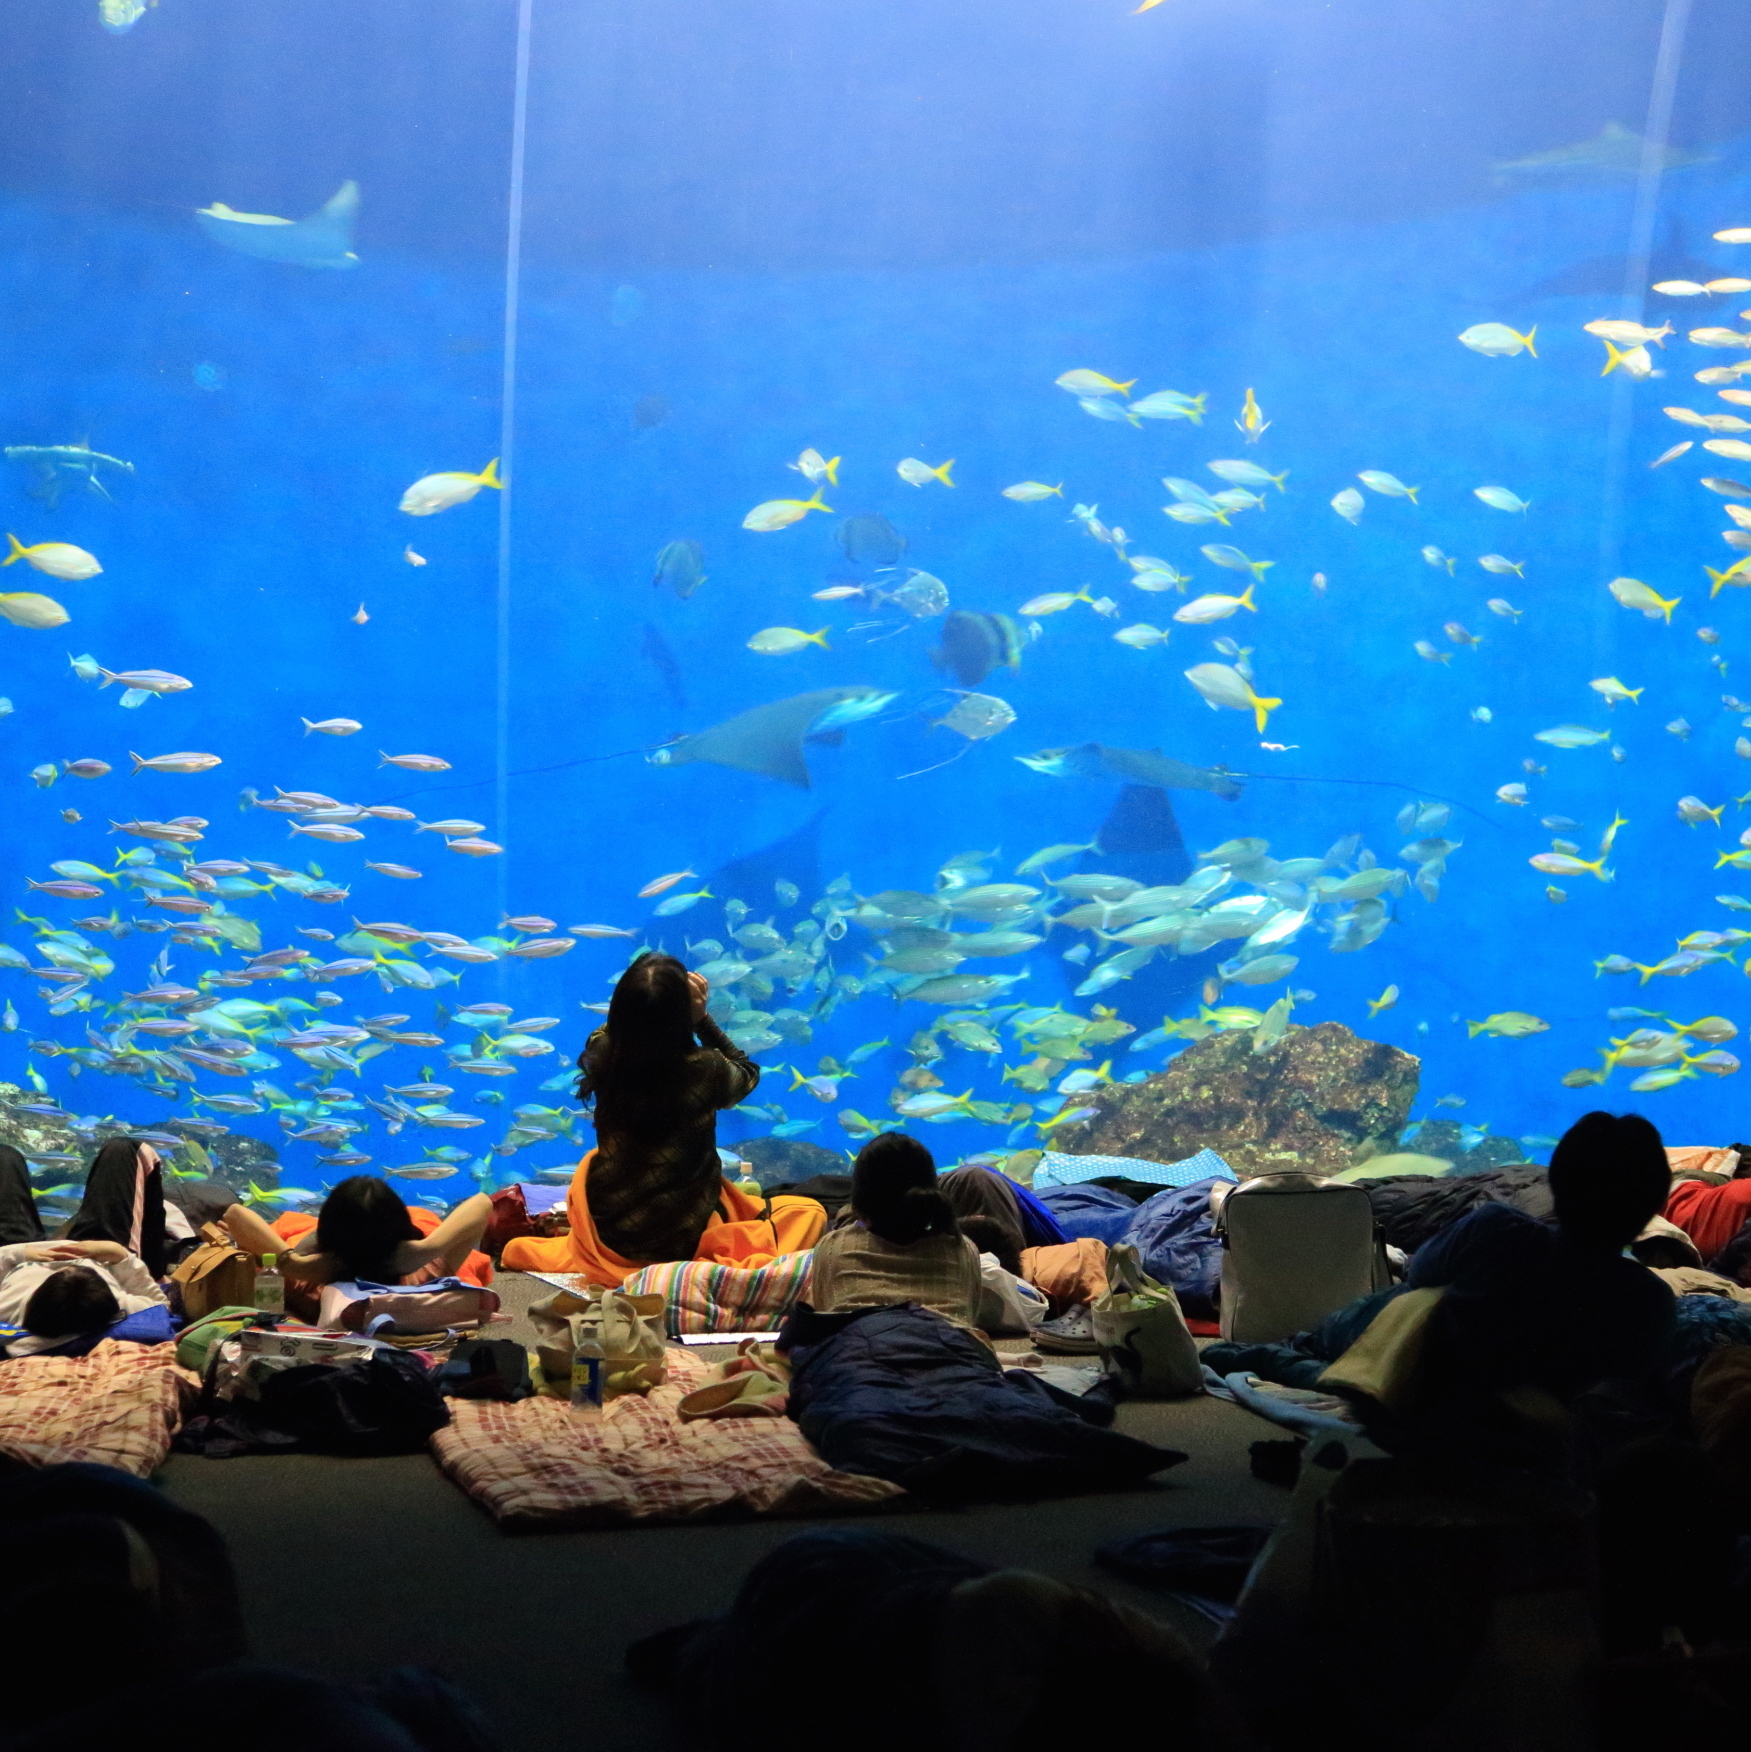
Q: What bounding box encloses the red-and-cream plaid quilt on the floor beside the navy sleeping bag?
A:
[431,1346,904,1533]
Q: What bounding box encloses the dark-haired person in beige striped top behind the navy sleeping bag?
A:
[808,1132,980,1328]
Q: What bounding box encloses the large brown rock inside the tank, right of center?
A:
[1053,1021,1421,1176]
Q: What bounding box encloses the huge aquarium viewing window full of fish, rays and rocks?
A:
[0,0,1751,1221]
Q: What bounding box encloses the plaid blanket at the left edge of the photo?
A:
[0,1339,200,1479]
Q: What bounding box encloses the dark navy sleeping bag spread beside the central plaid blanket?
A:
[778,1303,1187,1501]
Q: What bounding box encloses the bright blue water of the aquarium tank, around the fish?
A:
[10,0,1751,1193]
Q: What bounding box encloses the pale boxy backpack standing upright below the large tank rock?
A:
[1216,1172,1392,1344]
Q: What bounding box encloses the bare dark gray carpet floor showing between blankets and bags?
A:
[158,1274,1288,1752]
